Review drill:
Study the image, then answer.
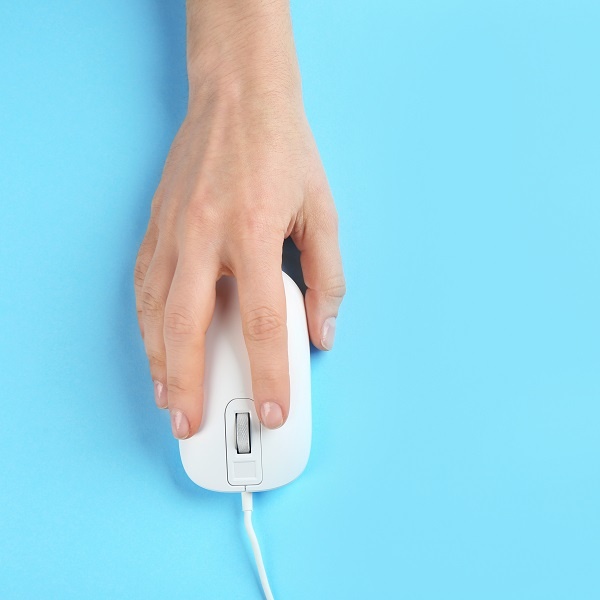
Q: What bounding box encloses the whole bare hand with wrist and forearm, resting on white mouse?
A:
[135,0,345,439]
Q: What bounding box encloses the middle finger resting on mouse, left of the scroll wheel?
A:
[163,251,218,439]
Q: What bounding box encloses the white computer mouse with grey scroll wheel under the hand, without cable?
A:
[179,273,312,492]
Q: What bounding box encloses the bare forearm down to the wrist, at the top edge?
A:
[187,0,300,100]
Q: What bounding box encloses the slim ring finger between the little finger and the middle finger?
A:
[141,242,177,408]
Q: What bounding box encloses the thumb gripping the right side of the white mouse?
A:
[292,194,346,350]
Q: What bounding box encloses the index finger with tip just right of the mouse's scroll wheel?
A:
[234,240,290,429]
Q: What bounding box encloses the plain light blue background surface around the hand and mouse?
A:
[0,0,600,600]
